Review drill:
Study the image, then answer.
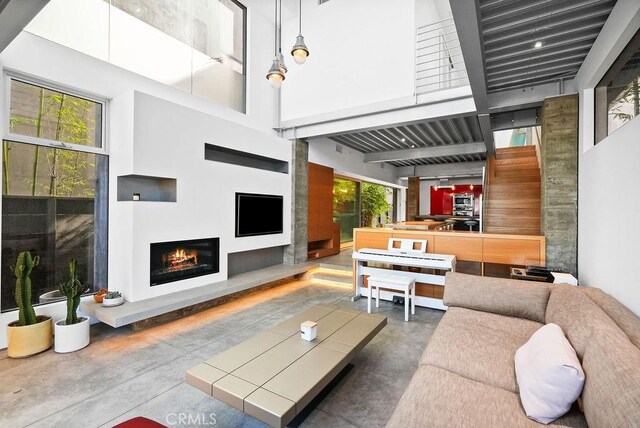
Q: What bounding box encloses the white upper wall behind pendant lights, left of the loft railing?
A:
[282,0,415,120]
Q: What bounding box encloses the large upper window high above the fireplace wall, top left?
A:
[26,0,246,113]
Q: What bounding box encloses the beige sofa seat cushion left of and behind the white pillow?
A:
[420,307,542,392]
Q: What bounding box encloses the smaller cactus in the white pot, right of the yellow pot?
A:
[54,259,89,353]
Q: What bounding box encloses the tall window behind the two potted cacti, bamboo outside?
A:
[0,78,108,312]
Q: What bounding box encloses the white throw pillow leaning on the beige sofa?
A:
[515,324,584,424]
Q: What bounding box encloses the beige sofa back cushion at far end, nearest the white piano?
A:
[443,272,549,323]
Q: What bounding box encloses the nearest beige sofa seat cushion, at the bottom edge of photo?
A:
[387,365,587,428]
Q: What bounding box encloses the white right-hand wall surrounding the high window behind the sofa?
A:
[576,0,640,315]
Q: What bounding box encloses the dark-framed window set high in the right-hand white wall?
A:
[595,30,640,143]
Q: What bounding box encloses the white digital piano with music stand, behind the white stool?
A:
[352,238,456,309]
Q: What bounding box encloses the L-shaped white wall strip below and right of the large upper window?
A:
[0,4,277,132]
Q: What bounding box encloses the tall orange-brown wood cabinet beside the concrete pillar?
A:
[307,163,340,258]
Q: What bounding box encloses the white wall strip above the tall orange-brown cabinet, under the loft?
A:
[309,137,401,187]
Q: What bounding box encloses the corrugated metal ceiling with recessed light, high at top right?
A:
[479,0,616,93]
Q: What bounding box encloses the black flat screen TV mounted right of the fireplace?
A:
[236,193,283,238]
